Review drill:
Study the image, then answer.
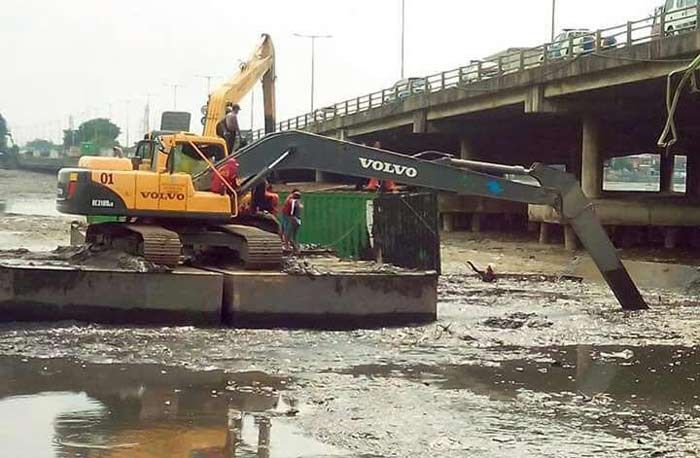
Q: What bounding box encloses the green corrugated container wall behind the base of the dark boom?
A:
[280,192,377,259]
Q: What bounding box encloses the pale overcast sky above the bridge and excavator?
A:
[0,0,662,143]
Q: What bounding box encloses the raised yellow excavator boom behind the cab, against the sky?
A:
[203,34,275,137]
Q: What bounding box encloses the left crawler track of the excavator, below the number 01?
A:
[86,223,182,267]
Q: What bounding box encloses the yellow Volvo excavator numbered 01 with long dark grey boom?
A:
[57,35,647,310]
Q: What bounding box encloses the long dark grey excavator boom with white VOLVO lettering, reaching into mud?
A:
[196,131,647,310]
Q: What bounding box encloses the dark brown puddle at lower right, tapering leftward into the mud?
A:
[336,345,700,444]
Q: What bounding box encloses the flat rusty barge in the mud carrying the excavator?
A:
[0,257,437,329]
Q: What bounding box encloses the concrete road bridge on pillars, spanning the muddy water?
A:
[260,7,700,247]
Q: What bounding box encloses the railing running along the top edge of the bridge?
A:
[252,6,700,140]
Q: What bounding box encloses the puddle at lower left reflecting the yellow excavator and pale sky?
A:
[0,357,344,458]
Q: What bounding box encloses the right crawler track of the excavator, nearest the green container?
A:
[217,224,282,269]
